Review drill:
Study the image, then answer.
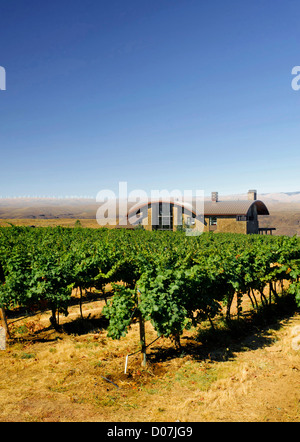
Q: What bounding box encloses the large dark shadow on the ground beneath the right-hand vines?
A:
[148,296,299,363]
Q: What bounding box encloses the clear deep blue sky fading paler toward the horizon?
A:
[0,0,300,196]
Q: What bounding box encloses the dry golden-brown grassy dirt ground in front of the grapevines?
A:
[0,301,300,422]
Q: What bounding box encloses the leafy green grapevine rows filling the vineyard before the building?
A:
[0,226,300,363]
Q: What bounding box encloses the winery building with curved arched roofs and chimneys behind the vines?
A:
[119,190,275,234]
